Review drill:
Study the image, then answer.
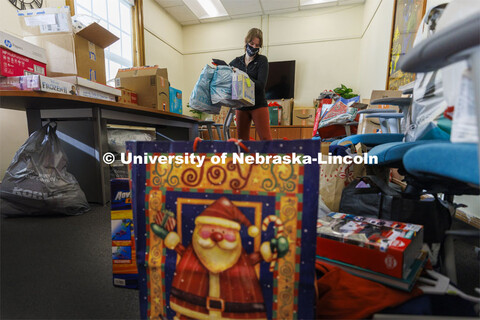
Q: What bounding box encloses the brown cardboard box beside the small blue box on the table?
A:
[115,66,170,111]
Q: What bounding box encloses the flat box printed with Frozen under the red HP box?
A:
[0,75,76,95]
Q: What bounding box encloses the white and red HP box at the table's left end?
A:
[0,31,47,77]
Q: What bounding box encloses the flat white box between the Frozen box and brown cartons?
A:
[55,76,121,102]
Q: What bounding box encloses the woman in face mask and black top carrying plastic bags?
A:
[230,28,272,140]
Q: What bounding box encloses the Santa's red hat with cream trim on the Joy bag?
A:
[195,197,260,237]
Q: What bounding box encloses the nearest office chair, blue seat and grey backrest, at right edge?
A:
[392,13,480,282]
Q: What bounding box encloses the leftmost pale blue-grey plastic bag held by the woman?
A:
[189,64,220,114]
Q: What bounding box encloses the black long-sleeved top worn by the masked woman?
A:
[230,54,268,110]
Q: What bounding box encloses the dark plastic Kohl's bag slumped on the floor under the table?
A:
[0,123,90,217]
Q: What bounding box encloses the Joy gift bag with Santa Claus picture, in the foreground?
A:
[128,140,320,319]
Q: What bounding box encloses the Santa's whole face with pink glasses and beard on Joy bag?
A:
[192,224,242,273]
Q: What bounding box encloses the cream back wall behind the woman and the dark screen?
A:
[183,5,364,106]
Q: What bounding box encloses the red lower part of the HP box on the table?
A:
[0,48,47,77]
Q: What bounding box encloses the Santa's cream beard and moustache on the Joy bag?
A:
[192,228,242,273]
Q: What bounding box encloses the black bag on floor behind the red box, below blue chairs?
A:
[340,176,452,244]
